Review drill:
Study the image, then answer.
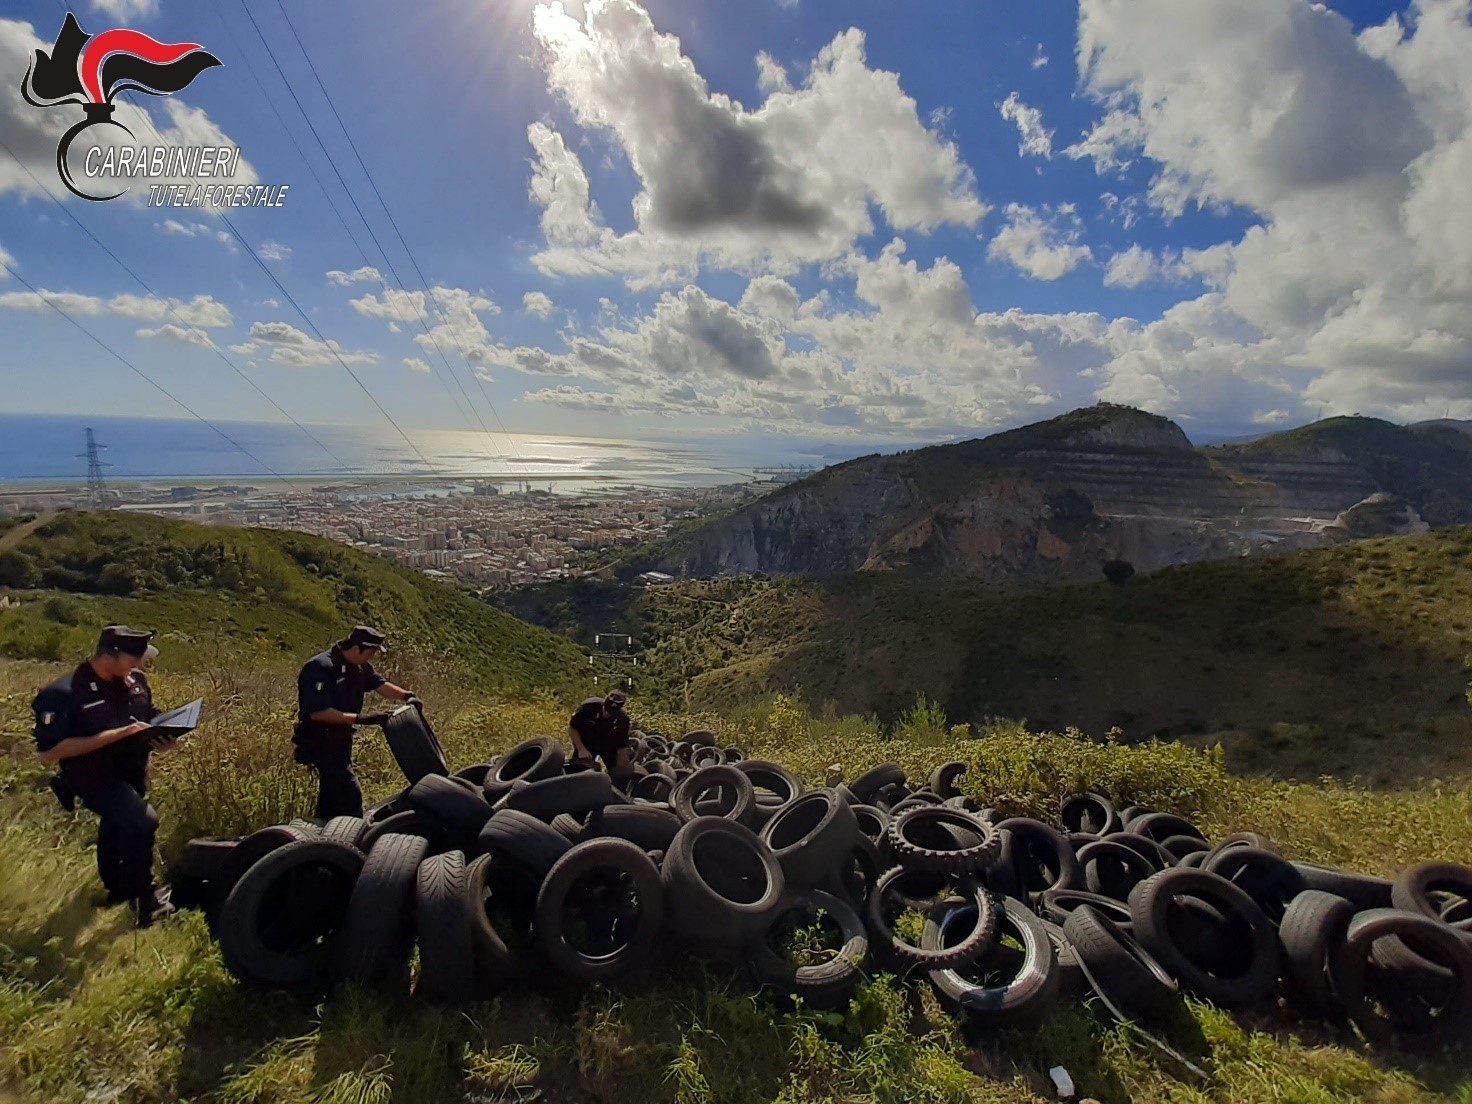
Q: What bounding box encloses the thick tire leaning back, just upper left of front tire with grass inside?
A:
[659,817,786,946]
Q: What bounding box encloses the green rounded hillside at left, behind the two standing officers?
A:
[0,512,586,693]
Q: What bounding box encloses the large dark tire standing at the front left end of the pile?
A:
[216,839,364,986]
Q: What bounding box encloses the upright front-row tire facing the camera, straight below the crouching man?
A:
[533,838,664,982]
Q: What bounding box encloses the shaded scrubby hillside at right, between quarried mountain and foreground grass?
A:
[512,527,1472,783]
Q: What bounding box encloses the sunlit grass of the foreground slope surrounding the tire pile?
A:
[0,662,1472,1104]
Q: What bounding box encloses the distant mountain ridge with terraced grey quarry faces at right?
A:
[621,403,1472,581]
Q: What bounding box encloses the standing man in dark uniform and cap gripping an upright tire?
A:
[291,624,424,818]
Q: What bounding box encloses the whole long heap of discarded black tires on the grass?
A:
[177,744,1472,1050]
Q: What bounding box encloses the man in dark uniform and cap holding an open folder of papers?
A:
[31,624,175,927]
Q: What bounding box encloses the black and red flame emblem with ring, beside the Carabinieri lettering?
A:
[21,12,221,202]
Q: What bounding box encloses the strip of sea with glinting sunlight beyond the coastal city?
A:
[0,414,871,490]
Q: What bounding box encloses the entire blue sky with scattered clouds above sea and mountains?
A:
[0,0,1472,445]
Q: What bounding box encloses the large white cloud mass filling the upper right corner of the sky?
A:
[1079,0,1472,420]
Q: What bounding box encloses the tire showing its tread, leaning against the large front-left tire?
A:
[333,835,428,991]
